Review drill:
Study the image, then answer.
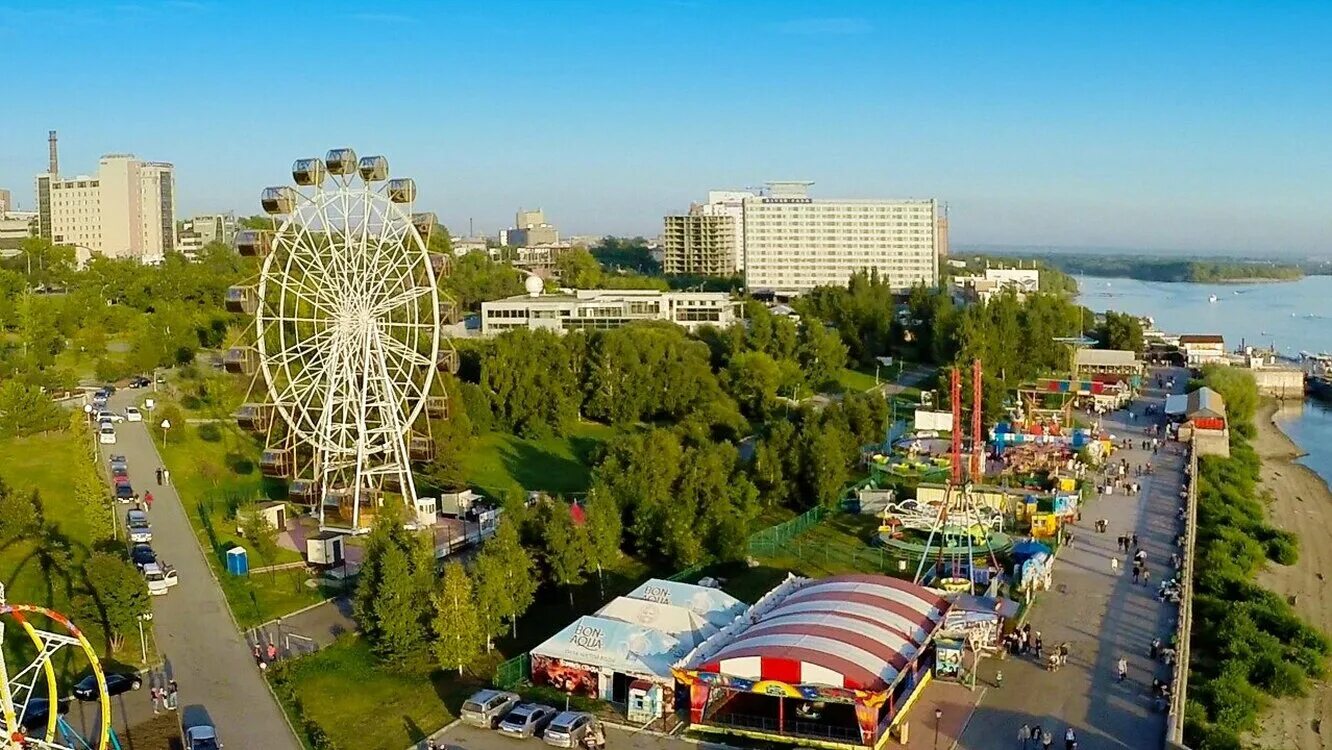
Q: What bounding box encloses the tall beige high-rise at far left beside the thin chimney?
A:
[37,153,176,261]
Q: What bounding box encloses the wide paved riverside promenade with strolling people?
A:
[952,369,1188,750]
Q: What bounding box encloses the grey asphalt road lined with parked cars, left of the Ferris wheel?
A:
[101,390,300,750]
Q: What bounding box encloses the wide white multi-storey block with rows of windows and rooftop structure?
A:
[743,183,939,296]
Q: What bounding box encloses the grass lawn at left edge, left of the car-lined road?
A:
[0,432,152,671]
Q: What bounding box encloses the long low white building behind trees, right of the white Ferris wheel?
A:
[481,286,739,336]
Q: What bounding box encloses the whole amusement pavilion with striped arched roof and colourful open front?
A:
[674,575,950,749]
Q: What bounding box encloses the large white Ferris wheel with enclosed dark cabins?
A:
[225,148,458,533]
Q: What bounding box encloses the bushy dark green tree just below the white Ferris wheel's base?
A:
[353,502,434,669]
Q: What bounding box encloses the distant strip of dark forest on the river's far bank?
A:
[975,252,1305,284]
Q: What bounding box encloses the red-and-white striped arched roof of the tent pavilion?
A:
[694,575,948,691]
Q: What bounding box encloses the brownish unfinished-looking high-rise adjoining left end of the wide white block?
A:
[662,190,754,276]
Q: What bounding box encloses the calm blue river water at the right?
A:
[1078,276,1332,482]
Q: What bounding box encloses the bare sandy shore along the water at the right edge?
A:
[1253,401,1332,750]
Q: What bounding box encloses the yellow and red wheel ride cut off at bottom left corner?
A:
[0,585,120,750]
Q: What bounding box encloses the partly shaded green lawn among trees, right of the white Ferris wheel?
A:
[464,422,615,497]
